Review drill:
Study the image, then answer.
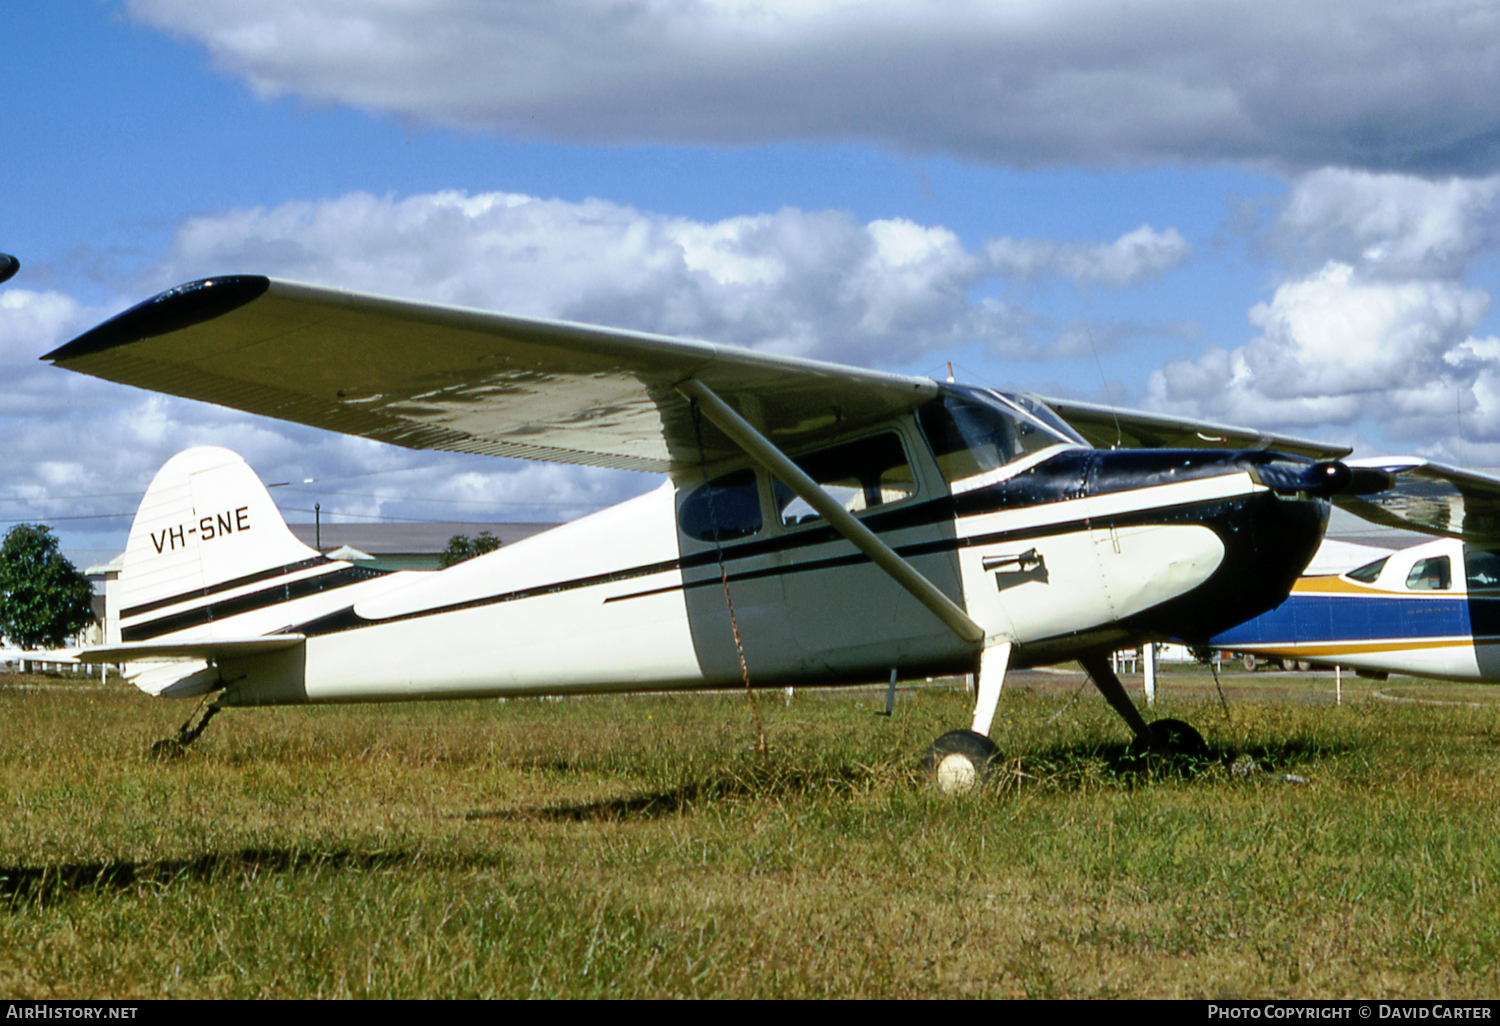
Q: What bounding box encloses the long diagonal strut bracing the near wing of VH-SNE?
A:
[677,378,984,644]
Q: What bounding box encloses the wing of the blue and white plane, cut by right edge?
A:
[1335,456,1500,549]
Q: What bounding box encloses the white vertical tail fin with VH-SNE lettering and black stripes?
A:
[117,446,329,642]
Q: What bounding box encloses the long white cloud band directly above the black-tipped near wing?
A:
[155,192,1158,366]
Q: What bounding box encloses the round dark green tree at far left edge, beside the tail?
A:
[0,524,93,648]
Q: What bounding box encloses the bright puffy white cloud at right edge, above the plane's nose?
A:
[1128,170,1500,461]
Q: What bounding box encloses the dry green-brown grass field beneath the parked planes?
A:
[0,674,1500,999]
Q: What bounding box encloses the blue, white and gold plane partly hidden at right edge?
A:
[1211,458,1500,681]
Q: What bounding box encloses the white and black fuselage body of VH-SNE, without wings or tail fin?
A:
[164,449,1328,705]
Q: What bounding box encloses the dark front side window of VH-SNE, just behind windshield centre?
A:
[917,392,1077,483]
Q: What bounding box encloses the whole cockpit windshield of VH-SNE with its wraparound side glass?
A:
[917,384,1088,483]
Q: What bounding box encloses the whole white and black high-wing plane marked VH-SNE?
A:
[44,276,1377,783]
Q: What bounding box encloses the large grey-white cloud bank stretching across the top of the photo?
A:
[126,0,1500,174]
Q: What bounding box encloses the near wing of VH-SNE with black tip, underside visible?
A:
[42,276,938,473]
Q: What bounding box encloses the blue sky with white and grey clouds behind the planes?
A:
[0,0,1500,552]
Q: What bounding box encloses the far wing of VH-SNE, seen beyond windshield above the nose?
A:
[1038,396,1353,459]
